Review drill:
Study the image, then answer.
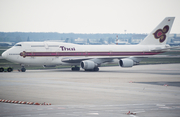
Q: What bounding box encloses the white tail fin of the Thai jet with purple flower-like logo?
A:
[139,17,175,45]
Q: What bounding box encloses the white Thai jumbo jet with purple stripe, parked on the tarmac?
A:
[2,17,175,72]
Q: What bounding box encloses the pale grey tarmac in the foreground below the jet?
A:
[0,64,180,117]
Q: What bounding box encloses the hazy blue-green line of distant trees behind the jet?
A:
[0,32,147,42]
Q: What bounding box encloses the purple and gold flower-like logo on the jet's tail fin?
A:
[153,25,169,43]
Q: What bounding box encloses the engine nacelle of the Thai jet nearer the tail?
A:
[119,59,134,67]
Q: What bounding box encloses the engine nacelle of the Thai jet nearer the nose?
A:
[81,60,96,69]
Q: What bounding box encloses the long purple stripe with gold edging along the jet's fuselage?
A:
[20,52,161,57]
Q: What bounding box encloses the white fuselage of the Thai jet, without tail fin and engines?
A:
[3,42,165,66]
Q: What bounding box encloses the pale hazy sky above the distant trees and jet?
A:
[0,0,180,34]
